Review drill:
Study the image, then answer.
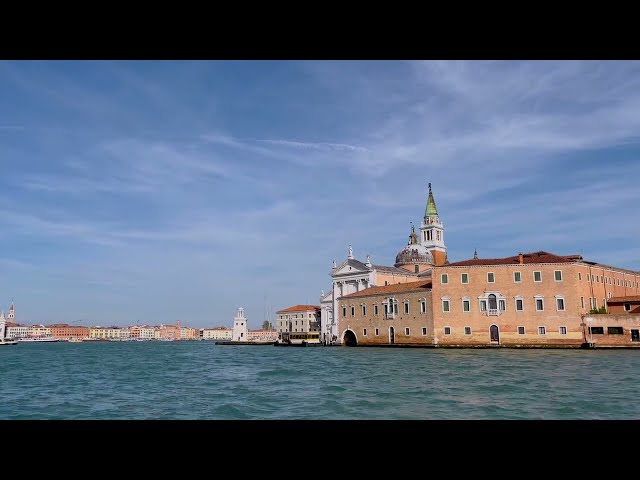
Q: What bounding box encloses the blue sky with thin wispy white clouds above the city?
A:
[0,61,640,328]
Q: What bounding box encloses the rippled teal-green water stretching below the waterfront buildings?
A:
[0,342,640,420]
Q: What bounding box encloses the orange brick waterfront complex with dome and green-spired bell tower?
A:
[336,182,640,347]
